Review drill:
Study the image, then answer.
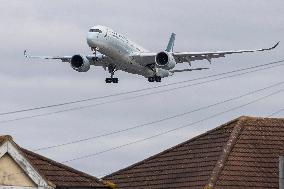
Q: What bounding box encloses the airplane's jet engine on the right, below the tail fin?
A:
[155,52,176,70]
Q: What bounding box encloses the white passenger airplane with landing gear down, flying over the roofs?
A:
[24,25,279,83]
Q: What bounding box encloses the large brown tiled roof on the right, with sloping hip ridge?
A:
[104,116,284,189]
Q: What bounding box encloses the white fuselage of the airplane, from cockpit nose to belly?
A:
[87,26,155,77]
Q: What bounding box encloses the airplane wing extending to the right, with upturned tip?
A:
[131,42,279,66]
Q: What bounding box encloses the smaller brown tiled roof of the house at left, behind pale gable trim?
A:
[0,136,113,188]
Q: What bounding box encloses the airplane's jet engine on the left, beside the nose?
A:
[70,55,91,72]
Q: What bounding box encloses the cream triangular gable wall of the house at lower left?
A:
[0,153,36,187]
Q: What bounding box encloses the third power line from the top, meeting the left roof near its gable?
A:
[33,81,284,151]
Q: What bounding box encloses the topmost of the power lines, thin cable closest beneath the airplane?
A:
[0,60,284,116]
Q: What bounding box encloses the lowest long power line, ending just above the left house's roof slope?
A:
[61,89,284,163]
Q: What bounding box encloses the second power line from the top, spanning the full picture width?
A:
[0,60,284,124]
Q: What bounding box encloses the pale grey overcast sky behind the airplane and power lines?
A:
[0,0,284,176]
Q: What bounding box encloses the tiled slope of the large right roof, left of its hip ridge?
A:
[105,117,238,189]
